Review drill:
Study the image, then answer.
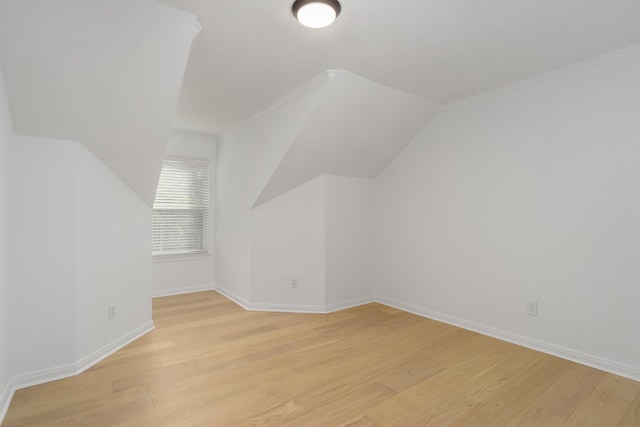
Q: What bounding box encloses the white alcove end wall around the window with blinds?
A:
[152,132,216,296]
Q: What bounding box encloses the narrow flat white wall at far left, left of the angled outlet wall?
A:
[9,137,80,376]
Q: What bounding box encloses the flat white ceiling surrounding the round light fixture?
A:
[158,0,640,134]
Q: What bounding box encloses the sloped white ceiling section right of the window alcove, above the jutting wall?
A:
[254,70,438,207]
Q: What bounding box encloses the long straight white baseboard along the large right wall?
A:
[376,296,640,381]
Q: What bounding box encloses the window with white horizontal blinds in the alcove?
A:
[152,158,209,255]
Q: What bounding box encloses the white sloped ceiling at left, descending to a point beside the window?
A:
[0,0,200,206]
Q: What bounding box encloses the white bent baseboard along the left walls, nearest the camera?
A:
[0,321,154,423]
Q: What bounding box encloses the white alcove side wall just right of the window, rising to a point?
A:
[215,78,323,302]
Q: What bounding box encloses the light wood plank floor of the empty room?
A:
[3,292,640,427]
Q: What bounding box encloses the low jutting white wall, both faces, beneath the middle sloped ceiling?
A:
[250,175,374,312]
